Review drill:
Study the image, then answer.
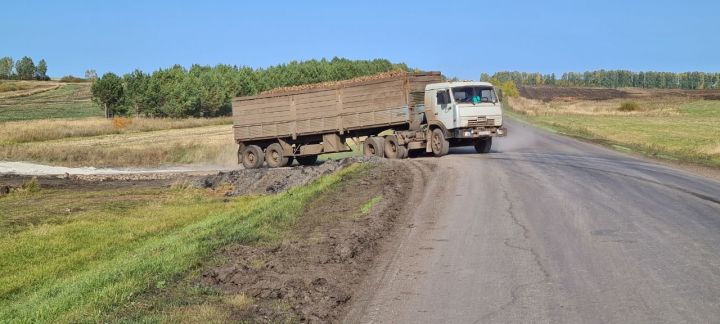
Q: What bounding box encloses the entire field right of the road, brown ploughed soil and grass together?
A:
[509,87,720,167]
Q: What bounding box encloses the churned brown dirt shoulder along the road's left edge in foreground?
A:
[198,162,420,323]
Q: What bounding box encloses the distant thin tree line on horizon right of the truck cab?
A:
[480,70,720,90]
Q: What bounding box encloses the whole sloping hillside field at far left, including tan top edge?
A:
[0,81,104,122]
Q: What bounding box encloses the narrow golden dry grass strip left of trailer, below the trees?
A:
[0,117,232,145]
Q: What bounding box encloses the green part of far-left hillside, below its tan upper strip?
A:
[0,83,104,122]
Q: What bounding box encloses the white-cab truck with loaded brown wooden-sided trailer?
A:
[232,72,507,169]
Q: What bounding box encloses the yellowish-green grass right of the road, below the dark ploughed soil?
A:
[510,101,720,167]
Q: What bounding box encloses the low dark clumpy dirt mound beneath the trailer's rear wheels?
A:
[196,157,383,196]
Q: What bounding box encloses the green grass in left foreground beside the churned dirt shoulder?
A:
[0,165,366,323]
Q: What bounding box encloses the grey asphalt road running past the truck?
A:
[346,121,720,323]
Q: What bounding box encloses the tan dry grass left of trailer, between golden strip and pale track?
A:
[0,121,237,167]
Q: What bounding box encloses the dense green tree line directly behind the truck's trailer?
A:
[91,58,408,117]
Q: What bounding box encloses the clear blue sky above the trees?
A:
[0,0,720,79]
